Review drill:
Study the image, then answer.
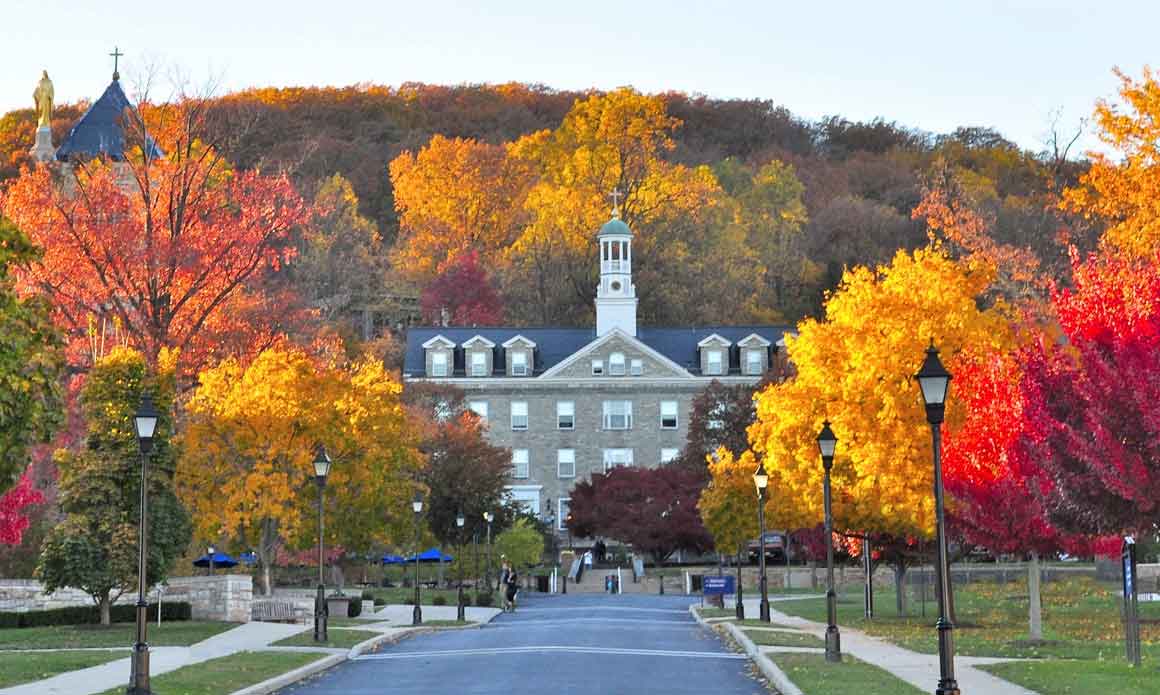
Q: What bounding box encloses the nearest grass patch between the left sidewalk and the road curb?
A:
[91,652,326,695]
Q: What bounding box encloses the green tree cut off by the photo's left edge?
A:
[0,217,64,493]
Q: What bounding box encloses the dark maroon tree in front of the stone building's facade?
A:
[568,465,712,564]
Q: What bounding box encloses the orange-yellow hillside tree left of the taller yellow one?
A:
[390,135,531,283]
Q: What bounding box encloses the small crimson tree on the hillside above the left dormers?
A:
[419,251,503,326]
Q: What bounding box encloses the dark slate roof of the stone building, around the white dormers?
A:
[403,326,793,376]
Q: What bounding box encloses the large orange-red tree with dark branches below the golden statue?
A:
[0,99,307,375]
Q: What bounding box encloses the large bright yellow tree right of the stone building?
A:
[749,247,1013,547]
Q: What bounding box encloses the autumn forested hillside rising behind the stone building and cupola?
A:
[0,84,1099,334]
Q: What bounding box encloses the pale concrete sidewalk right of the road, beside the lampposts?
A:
[728,596,1037,695]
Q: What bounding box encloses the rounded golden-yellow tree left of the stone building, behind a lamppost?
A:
[177,348,421,594]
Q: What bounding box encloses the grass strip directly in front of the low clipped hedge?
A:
[0,621,238,650]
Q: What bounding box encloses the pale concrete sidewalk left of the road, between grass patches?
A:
[0,623,306,695]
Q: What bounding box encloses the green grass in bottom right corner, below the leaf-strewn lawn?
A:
[978,659,1160,695]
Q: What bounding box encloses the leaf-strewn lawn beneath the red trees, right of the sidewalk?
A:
[775,578,1160,663]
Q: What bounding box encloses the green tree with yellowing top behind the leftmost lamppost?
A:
[37,348,191,624]
